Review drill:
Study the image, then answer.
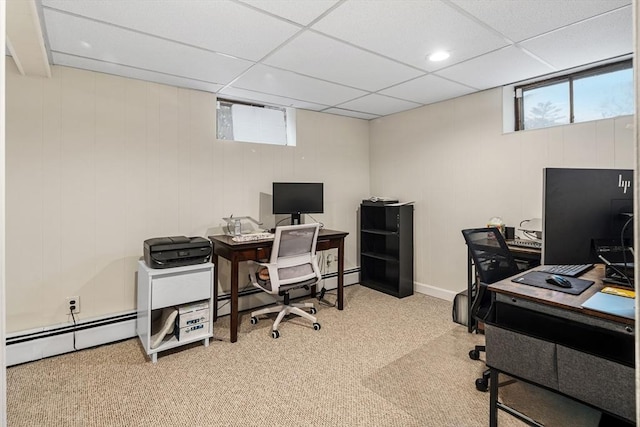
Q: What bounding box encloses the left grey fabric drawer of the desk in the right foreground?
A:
[484,324,558,390]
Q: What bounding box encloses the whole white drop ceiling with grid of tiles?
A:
[23,0,633,119]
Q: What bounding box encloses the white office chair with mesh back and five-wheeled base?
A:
[249,224,322,338]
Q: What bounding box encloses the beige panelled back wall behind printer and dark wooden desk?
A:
[6,58,369,332]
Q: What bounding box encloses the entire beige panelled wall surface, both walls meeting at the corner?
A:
[6,54,634,332]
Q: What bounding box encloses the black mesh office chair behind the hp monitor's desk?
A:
[462,227,520,391]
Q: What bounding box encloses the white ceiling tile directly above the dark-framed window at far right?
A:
[521,6,633,70]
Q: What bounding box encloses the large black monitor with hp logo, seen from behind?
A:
[542,168,634,264]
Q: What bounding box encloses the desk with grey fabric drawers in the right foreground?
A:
[485,265,635,427]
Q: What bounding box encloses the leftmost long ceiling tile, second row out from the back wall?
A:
[45,10,252,84]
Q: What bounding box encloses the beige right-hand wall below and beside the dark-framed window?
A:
[370,89,634,298]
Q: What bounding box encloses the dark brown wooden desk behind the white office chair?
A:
[209,229,349,342]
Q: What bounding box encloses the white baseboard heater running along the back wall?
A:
[5,268,360,366]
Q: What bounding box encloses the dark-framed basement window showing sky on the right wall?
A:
[515,60,635,130]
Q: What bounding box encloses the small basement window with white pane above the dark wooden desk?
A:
[216,99,296,146]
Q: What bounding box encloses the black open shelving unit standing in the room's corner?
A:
[360,200,413,298]
